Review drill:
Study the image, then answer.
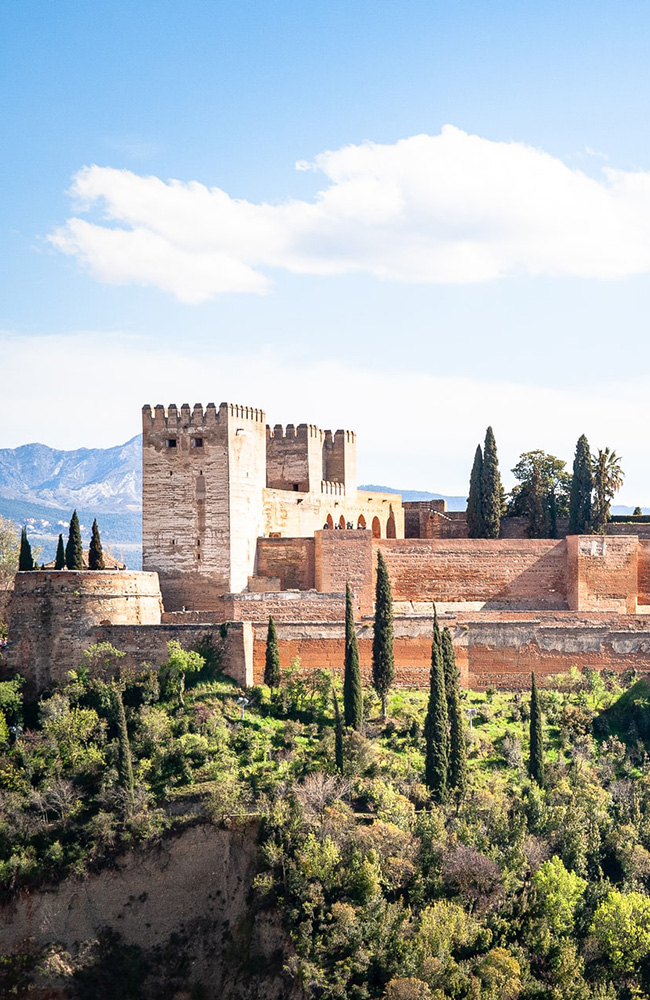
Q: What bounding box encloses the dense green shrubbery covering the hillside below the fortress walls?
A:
[0,646,650,1000]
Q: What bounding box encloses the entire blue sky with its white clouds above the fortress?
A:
[0,0,650,504]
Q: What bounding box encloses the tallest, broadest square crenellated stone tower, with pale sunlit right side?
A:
[142,403,266,610]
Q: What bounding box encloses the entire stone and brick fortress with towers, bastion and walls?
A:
[6,403,650,691]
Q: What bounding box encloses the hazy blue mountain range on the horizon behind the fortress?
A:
[0,434,650,569]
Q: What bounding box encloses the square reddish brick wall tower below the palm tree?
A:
[567,535,639,614]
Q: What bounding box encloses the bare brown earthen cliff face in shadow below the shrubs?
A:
[0,822,301,1000]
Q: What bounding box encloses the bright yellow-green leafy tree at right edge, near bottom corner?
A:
[591,890,650,972]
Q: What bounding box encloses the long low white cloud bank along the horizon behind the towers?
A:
[0,333,650,505]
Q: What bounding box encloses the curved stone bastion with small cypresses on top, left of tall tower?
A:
[7,570,163,691]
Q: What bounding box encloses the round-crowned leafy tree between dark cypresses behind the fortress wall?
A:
[508,449,571,538]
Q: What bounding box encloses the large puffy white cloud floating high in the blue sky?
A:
[48,125,650,303]
